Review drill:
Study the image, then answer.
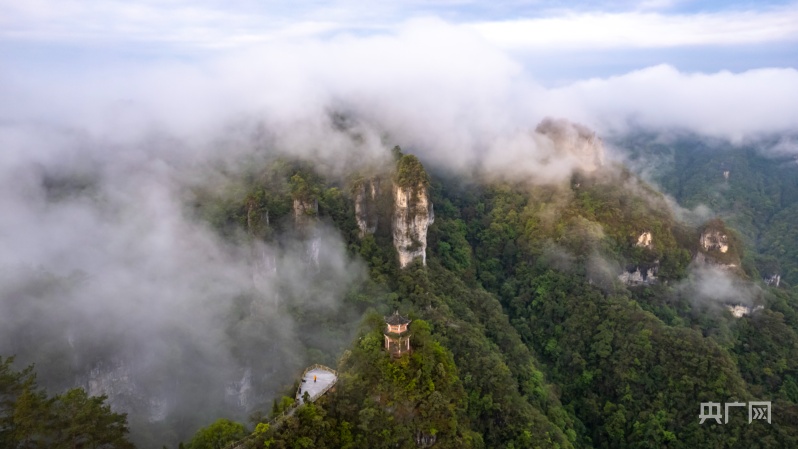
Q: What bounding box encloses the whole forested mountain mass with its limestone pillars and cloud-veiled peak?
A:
[1,120,798,449]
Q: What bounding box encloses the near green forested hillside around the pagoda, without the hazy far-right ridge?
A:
[177,138,798,448]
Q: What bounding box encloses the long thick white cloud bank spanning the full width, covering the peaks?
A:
[0,20,798,166]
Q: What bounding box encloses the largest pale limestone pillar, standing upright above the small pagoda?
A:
[392,183,435,268]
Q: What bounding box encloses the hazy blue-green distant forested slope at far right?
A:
[616,134,798,285]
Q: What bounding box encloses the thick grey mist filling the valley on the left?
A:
[0,126,365,446]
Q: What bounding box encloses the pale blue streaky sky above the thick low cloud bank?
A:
[0,0,798,85]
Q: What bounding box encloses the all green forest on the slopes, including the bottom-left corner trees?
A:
[0,135,798,449]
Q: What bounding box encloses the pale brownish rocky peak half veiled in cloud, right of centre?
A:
[535,118,604,172]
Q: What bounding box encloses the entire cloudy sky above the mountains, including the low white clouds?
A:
[0,0,798,146]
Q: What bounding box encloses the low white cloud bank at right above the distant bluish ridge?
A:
[546,65,798,140]
